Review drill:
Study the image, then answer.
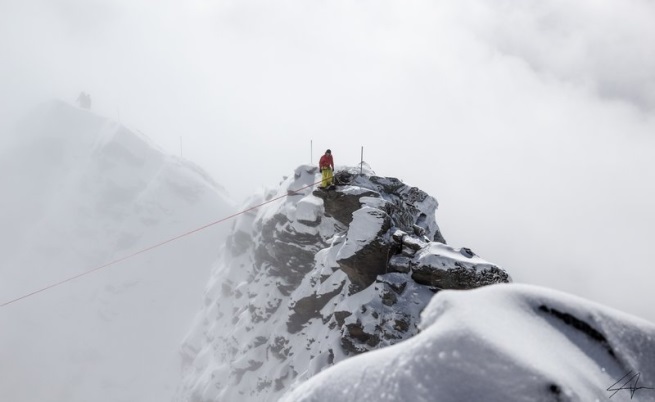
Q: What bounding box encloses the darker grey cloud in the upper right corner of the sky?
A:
[463,0,655,112]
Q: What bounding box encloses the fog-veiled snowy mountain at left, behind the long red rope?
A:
[0,101,233,402]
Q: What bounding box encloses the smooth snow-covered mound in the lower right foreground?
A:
[282,285,655,402]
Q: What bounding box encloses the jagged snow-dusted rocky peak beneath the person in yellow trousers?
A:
[178,166,510,401]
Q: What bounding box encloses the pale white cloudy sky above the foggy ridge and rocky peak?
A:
[0,0,655,321]
